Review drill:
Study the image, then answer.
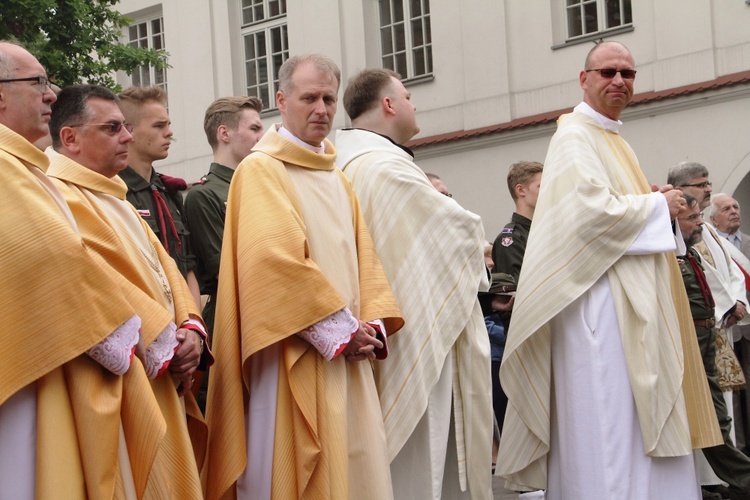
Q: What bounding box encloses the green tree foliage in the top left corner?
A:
[0,0,168,91]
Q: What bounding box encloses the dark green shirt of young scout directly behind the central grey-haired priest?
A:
[185,163,234,330]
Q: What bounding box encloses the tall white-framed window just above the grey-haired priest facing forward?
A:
[240,0,289,109]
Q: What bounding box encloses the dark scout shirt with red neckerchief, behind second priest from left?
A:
[118,167,196,278]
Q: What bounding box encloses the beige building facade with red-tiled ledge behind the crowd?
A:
[118,0,750,241]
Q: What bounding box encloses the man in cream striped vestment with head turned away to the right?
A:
[336,69,492,499]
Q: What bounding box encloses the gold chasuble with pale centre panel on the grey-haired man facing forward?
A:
[204,127,403,499]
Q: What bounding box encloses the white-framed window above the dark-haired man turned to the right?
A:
[380,0,432,79]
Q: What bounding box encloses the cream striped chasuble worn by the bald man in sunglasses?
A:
[498,112,722,489]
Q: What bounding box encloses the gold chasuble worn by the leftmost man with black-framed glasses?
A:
[0,125,138,499]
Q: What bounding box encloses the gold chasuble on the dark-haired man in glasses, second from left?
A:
[48,154,207,499]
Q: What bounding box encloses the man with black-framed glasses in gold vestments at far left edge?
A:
[0,41,142,498]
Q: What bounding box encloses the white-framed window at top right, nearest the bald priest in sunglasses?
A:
[565,0,633,38]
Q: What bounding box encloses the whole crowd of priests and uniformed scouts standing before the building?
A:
[0,36,750,500]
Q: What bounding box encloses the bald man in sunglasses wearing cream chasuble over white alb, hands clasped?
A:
[497,42,721,500]
